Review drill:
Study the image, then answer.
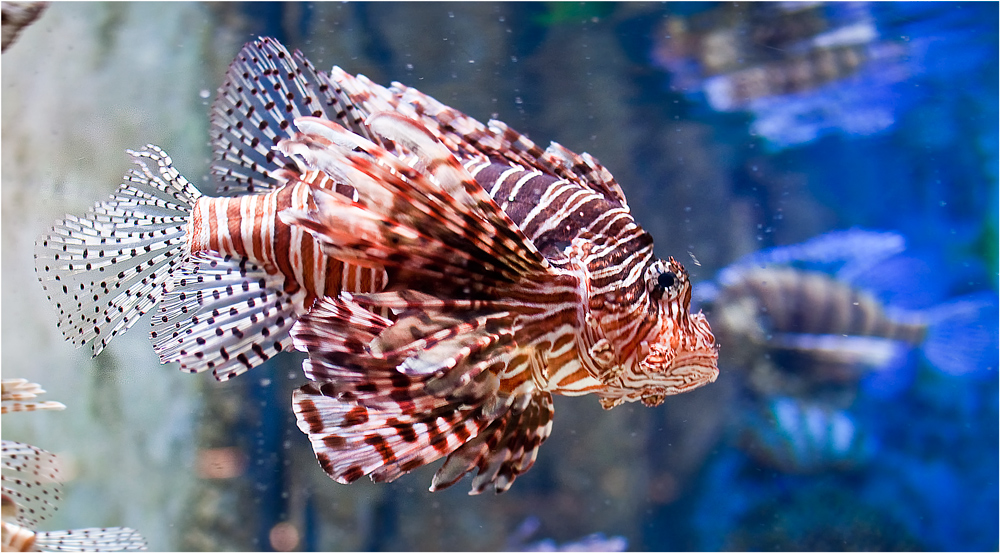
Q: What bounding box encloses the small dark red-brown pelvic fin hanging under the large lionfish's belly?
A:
[430,390,554,495]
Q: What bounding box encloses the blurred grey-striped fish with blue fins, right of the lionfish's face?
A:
[695,229,996,395]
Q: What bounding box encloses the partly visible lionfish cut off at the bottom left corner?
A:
[0,378,146,551]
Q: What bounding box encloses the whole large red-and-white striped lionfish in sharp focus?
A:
[36,38,718,493]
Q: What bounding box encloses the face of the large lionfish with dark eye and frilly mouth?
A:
[601,257,719,408]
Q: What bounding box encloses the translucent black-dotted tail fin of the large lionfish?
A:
[35,145,201,356]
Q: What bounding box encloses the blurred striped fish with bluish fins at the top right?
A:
[653,2,921,149]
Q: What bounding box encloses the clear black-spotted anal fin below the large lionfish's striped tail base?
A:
[151,253,307,380]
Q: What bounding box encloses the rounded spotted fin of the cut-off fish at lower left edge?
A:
[0,440,62,528]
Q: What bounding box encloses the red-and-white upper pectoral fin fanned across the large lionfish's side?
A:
[278,116,549,288]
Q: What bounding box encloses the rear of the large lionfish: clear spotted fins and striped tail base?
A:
[36,39,385,380]
